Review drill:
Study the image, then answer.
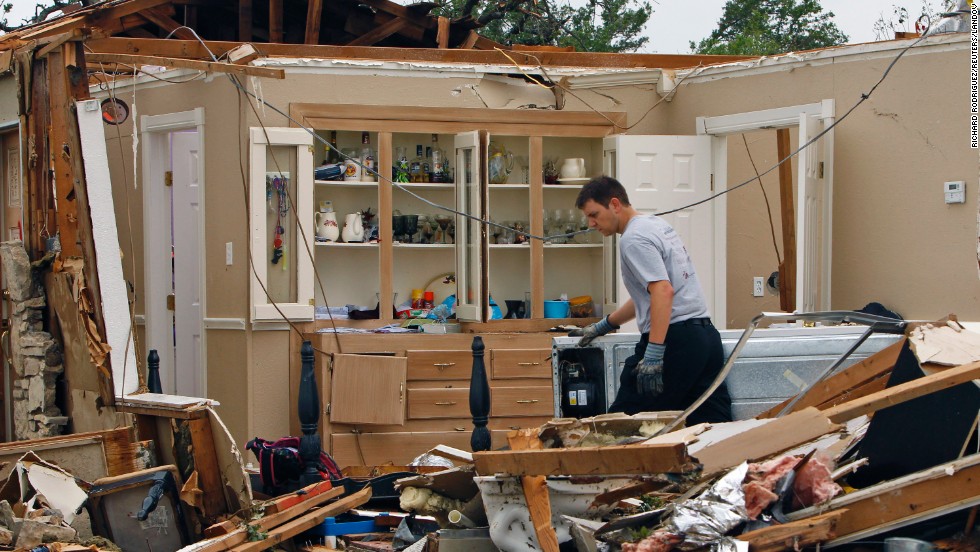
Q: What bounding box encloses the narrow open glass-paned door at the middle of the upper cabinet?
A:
[455,131,489,322]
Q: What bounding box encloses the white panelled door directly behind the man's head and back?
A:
[603,135,725,332]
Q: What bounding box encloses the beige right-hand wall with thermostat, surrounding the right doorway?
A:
[667,44,980,327]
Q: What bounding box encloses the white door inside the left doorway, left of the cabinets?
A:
[171,132,205,397]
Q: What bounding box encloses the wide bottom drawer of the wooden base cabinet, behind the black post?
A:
[330,430,508,468]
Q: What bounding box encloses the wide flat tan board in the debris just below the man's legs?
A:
[691,407,840,477]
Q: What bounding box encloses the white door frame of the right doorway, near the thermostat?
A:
[696,99,836,310]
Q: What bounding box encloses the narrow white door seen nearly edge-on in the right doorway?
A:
[796,113,830,312]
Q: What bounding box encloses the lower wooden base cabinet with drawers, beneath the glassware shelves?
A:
[308,333,554,466]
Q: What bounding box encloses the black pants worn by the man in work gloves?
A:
[609,318,732,425]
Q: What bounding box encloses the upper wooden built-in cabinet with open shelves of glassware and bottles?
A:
[291,104,625,326]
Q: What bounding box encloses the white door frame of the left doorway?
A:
[140,107,207,397]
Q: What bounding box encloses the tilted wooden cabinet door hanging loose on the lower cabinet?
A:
[330,354,408,425]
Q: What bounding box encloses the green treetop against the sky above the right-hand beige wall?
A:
[691,0,847,56]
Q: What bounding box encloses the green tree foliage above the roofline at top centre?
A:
[433,0,653,52]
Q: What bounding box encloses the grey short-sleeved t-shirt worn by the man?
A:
[619,215,709,333]
